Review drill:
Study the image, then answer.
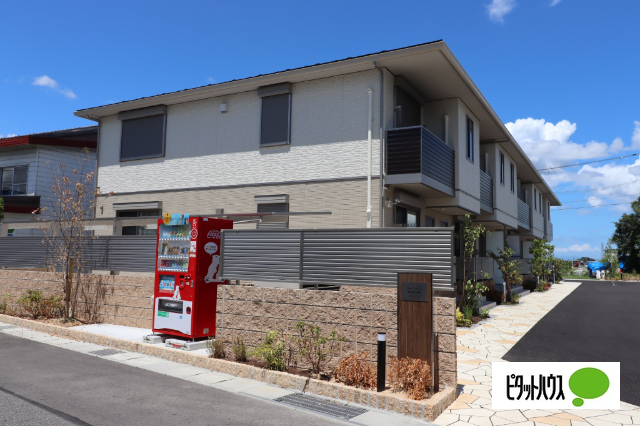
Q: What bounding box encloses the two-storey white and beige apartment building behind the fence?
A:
[75,41,560,282]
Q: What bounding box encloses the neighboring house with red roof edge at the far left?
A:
[0,126,98,236]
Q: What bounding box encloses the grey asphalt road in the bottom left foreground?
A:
[0,333,347,426]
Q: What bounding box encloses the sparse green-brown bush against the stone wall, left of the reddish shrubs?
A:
[292,321,345,374]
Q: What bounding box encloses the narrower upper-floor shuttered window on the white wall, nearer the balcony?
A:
[258,83,291,146]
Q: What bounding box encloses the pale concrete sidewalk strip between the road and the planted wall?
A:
[0,323,429,426]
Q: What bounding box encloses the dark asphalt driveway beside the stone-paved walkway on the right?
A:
[504,281,640,406]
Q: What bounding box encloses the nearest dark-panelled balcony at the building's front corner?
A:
[386,126,455,197]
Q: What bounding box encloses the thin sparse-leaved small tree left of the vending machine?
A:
[40,149,112,319]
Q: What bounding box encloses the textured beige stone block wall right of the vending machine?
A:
[216,286,457,388]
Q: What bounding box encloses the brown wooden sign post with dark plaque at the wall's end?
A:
[398,273,437,390]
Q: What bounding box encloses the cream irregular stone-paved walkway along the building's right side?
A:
[434,283,640,426]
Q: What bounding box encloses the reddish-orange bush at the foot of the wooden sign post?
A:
[389,357,431,400]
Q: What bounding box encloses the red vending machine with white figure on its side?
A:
[153,213,233,339]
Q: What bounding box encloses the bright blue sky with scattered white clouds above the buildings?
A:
[0,0,640,257]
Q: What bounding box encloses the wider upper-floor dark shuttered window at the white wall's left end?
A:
[118,105,167,161]
